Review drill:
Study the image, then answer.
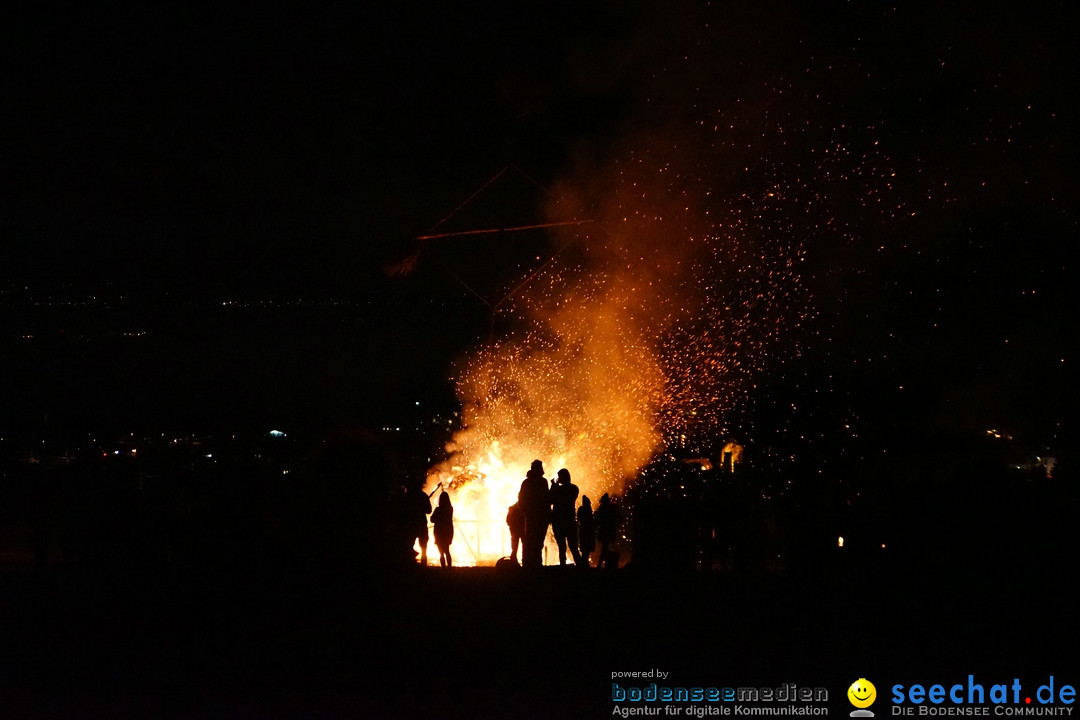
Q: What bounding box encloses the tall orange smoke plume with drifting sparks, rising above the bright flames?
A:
[425,2,896,505]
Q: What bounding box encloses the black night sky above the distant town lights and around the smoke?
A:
[0,2,1078,445]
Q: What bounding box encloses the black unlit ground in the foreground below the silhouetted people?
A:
[0,561,1078,718]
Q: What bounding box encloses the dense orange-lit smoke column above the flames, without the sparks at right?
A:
[429,132,768,494]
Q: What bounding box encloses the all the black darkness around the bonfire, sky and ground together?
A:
[0,2,1078,717]
